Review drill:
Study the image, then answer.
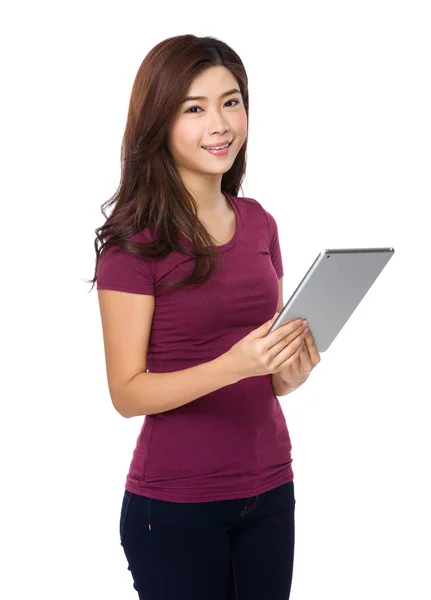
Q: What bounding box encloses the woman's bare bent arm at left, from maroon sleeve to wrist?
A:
[98,289,241,418]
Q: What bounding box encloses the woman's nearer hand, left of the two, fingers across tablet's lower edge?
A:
[226,313,307,380]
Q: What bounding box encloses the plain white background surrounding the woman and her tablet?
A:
[0,0,431,600]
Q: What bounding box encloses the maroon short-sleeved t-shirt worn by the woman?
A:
[97,194,293,502]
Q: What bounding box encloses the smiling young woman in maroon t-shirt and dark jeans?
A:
[91,35,320,600]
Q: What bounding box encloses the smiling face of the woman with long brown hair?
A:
[168,66,247,178]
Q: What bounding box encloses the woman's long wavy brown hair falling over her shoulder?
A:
[87,35,249,291]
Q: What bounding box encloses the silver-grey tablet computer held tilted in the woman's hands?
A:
[265,248,395,352]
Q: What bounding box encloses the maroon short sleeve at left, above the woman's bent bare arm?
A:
[96,247,155,296]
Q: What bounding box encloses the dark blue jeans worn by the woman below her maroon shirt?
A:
[120,481,296,600]
